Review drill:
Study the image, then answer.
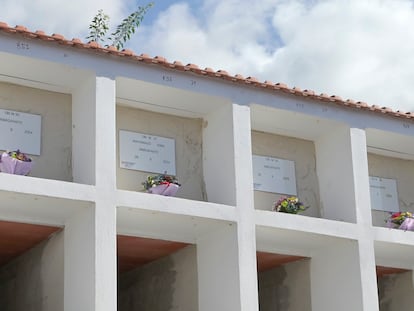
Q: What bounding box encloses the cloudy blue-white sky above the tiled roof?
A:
[0,0,414,111]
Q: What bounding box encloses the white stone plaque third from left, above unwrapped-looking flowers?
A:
[253,155,297,195]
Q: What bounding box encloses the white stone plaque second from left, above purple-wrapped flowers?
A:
[119,130,176,176]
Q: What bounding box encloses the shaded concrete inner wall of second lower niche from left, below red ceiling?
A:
[118,246,198,311]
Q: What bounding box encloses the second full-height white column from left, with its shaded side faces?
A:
[201,104,258,311]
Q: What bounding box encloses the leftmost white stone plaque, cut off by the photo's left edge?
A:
[0,109,42,155]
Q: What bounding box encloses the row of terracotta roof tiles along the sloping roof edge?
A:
[0,21,414,119]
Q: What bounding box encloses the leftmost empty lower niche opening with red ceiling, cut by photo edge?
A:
[0,221,64,311]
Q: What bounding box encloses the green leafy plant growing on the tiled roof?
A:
[86,2,154,50]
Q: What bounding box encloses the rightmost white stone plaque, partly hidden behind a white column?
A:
[369,176,400,212]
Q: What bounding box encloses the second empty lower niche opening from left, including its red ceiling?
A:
[117,235,198,311]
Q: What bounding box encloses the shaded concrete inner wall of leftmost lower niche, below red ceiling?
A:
[0,232,63,311]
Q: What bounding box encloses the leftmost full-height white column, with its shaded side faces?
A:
[64,77,117,311]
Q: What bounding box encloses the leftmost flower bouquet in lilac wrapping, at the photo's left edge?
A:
[0,150,33,175]
